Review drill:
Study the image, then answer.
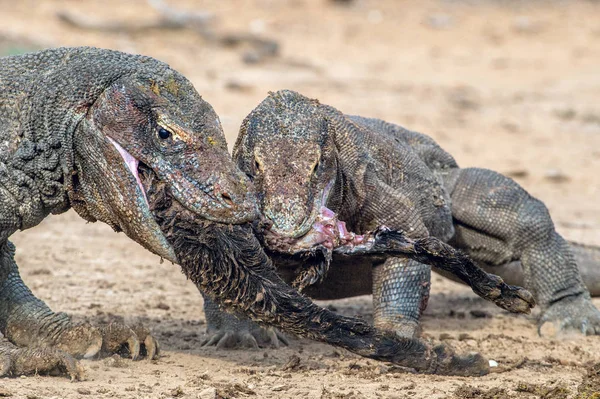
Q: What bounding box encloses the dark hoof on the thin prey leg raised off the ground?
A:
[480,274,535,314]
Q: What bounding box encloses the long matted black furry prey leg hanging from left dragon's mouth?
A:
[143,173,489,375]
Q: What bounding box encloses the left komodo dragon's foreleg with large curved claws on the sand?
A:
[0,241,157,378]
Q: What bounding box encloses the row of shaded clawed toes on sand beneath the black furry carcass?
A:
[202,327,289,349]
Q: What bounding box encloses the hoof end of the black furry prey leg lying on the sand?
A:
[432,345,490,377]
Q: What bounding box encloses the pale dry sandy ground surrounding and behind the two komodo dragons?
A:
[0,0,600,398]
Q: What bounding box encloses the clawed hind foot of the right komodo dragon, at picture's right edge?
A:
[538,293,600,337]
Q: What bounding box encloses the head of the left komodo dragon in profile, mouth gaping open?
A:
[70,68,258,261]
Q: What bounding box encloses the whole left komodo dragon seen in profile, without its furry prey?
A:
[0,48,256,378]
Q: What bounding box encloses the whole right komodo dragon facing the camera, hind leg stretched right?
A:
[225,91,600,342]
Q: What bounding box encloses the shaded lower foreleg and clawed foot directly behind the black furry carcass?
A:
[202,294,289,349]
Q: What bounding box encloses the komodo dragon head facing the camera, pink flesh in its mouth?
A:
[233,90,338,253]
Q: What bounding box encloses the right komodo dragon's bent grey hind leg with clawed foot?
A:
[446,168,600,334]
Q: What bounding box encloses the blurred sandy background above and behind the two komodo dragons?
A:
[0,0,600,241]
